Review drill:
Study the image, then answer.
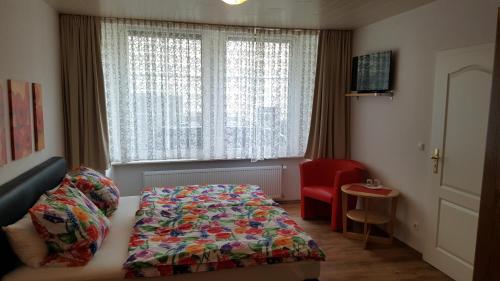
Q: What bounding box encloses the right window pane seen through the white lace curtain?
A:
[225,40,290,158]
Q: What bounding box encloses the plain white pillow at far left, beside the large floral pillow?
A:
[2,214,49,267]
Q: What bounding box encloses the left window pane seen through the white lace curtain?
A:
[128,32,202,159]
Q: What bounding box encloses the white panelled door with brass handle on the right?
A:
[423,44,494,281]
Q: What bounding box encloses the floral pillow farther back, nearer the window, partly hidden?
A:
[69,167,120,217]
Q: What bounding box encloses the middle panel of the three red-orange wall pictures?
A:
[8,80,33,160]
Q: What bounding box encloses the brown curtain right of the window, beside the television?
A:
[305,30,352,159]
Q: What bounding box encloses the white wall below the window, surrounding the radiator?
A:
[110,158,304,200]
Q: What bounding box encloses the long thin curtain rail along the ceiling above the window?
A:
[60,13,348,32]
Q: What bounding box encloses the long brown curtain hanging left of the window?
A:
[59,15,109,171]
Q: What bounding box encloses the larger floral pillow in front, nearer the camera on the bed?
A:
[29,183,111,266]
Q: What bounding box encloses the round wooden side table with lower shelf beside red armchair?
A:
[341,183,400,248]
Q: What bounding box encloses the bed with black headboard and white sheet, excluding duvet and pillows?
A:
[0,157,320,281]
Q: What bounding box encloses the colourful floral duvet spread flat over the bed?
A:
[124,185,324,278]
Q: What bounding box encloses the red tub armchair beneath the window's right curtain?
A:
[300,159,368,231]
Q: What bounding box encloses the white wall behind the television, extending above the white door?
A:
[351,0,499,251]
